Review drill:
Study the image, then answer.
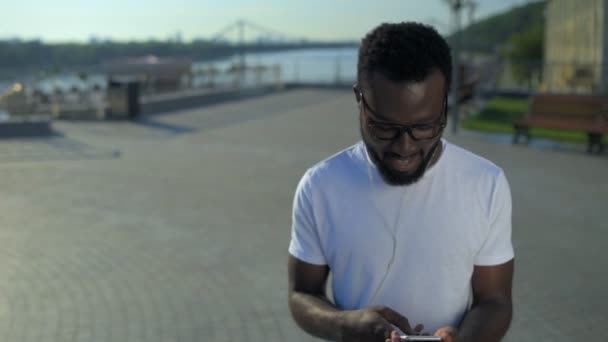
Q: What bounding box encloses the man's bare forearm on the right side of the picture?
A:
[458,302,513,342]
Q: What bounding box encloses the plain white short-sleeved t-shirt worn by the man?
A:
[289,140,514,332]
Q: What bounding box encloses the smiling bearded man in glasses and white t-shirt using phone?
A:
[289,23,514,342]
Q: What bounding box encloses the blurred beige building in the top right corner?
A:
[543,0,608,94]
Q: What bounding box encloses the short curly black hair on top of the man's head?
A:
[357,22,452,92]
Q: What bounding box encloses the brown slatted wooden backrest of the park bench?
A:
[528,94,608,122]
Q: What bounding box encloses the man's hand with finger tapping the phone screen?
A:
[340,306,423,342]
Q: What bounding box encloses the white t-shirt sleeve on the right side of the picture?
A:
[475,171,514,266]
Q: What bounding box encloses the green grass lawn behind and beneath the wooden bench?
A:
[461,97,608,144]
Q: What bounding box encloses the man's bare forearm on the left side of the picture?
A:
[289,292,342,341]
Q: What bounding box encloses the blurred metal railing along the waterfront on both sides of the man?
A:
[0,53,608,118]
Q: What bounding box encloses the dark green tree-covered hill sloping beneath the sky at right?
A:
[448,1,546,52]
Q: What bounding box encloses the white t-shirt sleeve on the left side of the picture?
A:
[289,171,327,265]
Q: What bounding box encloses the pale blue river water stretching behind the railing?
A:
[0,47,357,94]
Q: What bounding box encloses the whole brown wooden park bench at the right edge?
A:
[513,94,608,153]
